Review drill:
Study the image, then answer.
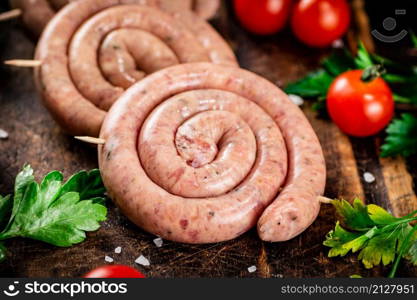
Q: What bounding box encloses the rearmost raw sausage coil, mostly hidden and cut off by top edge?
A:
[10,0,220,36]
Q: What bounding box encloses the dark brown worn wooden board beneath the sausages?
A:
[0,2,417,277]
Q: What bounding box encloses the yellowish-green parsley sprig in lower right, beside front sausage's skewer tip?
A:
[323,199,417,277]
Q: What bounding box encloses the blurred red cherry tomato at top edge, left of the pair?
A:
[233,0,291,35]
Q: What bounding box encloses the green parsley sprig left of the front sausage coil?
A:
[0,165,107,260]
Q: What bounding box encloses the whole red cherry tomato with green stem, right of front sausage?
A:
[327,70,394,137]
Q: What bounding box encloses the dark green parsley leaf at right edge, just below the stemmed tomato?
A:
[381,114,417,157]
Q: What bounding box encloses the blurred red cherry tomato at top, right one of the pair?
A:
[291,0,350,47]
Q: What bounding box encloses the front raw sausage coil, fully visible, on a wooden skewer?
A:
[98,63,326,243]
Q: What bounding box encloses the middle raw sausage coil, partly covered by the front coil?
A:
[35,0,237,136]
